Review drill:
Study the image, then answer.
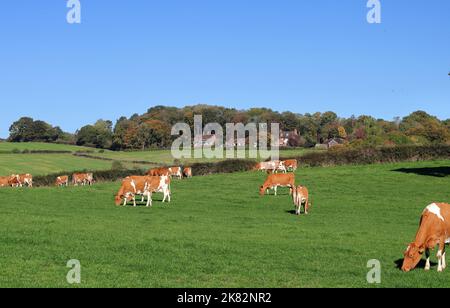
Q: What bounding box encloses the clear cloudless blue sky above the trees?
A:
[0,0,450,137]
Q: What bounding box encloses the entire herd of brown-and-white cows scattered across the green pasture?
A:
[0,160,450,272]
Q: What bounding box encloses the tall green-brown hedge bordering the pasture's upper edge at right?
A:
[288,145,450,167]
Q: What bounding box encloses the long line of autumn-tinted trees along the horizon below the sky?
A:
[8,105,450,150]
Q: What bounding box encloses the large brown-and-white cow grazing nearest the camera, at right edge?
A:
[402,203,450,272]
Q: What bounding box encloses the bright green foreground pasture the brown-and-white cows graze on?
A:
[0,161,450,288]
